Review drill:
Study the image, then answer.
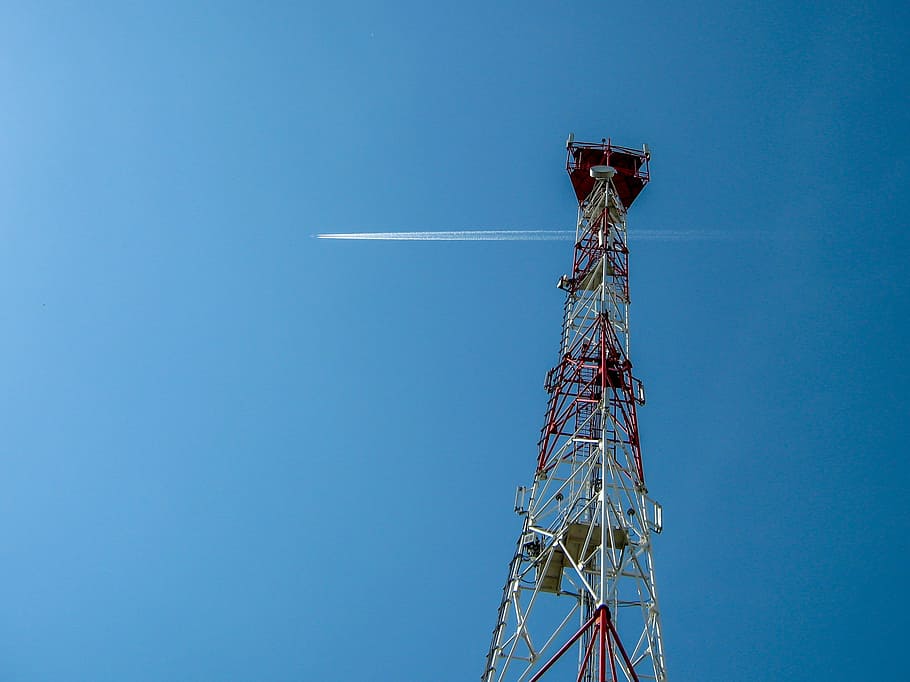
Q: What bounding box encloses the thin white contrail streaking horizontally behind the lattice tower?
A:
[313,229,744,242]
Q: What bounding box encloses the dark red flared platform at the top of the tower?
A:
[566,135,651,208]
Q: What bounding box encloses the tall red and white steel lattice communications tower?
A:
[481,135,667,682]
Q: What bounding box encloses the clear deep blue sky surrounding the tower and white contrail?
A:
[0,0,910,682]
